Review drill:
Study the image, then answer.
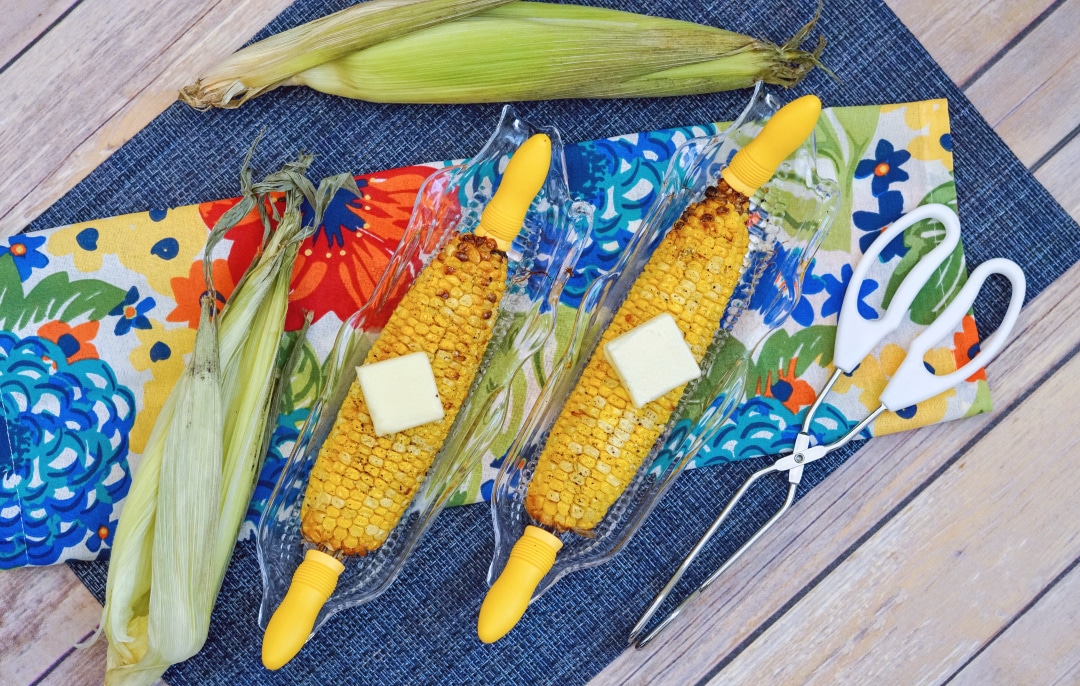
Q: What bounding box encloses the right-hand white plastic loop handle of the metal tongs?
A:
[881,257,1027,412]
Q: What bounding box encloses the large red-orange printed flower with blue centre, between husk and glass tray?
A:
[285,166,435,331]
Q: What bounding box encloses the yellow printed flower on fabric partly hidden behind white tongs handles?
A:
[834,344,956,435]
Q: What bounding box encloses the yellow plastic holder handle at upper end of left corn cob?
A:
[476,133,551,252]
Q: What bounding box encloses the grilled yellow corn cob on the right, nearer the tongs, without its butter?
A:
[525,180,750,532]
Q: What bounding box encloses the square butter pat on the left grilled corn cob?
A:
[356,352,445,435]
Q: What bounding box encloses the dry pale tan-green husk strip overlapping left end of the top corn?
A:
[180,0,511,109]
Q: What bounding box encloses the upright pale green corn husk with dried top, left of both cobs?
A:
[102,154,359,685]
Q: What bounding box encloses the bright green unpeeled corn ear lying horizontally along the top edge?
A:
[185,2,824,104]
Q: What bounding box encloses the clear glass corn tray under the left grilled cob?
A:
[257,107,592,635]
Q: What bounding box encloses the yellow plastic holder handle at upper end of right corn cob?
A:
[720,95,821,198]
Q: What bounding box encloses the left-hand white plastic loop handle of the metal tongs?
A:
[833,203,960,374]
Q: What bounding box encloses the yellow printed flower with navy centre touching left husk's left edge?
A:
[129,320,195,453]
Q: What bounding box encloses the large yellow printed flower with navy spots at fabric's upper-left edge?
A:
[49,205,207,296]
